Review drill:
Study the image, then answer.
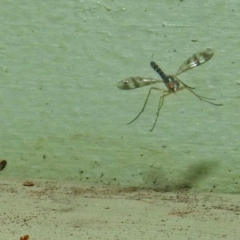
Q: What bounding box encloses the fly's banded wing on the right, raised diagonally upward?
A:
[176,48,214,75]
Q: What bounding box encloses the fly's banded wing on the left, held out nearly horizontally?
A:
[117,77,162,90]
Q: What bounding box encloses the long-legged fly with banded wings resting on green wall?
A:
[117,48,223,132]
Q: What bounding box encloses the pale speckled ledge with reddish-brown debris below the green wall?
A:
[0,179,240,240]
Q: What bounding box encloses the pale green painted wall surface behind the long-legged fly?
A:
[0,0,240,193]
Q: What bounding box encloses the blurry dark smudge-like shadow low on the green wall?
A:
[143,161,218,192]
